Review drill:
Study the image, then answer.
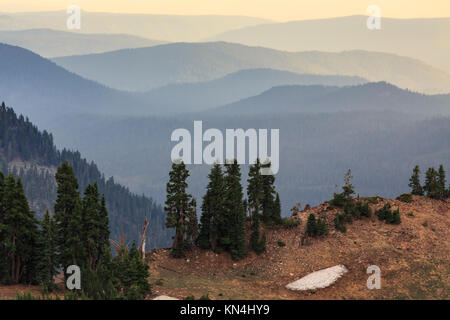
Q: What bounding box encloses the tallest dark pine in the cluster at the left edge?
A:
[54,162,86,270]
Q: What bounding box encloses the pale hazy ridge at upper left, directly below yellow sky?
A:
[0,10,271,42]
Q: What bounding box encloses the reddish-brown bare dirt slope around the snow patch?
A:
[148,197,450,299]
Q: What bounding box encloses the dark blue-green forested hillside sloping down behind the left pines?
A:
[0,103,170,247]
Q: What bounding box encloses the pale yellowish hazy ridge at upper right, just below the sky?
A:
[205,16,450,74]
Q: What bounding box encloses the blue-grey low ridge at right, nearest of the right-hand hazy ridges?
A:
[214,82,450,115]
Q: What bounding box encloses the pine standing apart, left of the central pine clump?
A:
[164,161,193,257]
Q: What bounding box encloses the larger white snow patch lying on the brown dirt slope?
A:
[286,264,348,291]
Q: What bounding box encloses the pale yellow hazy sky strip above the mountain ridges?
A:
[0,0,450,21]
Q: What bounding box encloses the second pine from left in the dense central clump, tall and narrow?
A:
[225,160,247,260]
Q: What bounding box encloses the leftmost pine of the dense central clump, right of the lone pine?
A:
[197,163,227,250]
